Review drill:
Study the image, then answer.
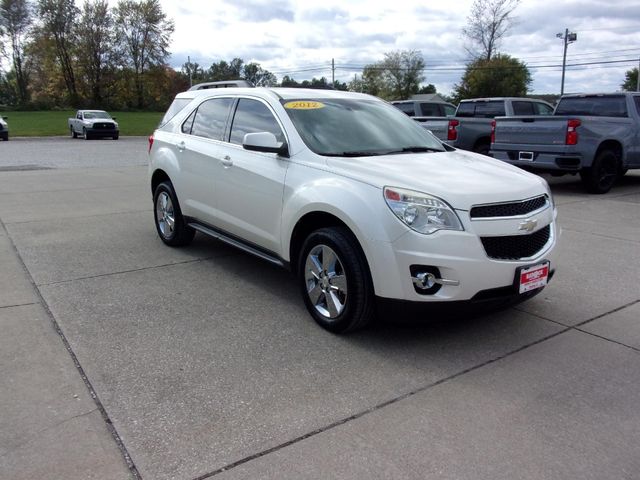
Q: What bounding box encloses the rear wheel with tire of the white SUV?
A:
[153,181,196,247]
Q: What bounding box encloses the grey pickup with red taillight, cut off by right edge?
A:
[490,93,640,193]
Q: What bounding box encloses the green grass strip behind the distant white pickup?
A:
[0,110,164,137]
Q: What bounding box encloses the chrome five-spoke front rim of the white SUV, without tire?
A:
[304,245,347,319]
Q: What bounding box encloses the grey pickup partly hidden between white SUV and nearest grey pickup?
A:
[421,97,553,155]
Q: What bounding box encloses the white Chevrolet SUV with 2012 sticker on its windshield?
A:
[149,88,558,332]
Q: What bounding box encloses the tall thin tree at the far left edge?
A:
[0,0,33,105]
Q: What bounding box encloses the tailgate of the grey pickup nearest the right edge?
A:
[495,116,569,145]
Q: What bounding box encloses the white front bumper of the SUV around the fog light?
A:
[370,207,559,303]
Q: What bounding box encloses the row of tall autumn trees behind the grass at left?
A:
[0,0,177,109]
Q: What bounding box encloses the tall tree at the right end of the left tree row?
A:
[115,0,174,108]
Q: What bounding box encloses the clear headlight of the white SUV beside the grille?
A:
[384,187,464,235]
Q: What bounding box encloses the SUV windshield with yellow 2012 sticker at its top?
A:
[282,98,444,157]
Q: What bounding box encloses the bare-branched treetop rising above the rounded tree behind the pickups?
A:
[462,0,521,60]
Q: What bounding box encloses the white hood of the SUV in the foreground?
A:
[326,150,547,210]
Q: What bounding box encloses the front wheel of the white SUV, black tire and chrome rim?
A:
[298,227,374,333]
